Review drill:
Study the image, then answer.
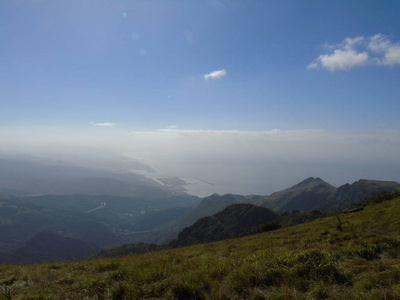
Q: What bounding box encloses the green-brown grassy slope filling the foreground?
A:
[0,198,400,299]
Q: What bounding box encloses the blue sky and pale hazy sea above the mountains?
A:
[0,0,400,194]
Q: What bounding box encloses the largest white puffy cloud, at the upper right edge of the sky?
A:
[307,34,400,72]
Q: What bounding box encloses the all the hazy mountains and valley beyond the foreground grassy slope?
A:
[0,159,400,263]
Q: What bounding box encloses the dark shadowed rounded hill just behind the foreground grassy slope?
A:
[96,204,332,257]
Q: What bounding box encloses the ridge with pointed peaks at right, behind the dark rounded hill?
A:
[127,177,400,243]
